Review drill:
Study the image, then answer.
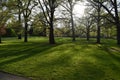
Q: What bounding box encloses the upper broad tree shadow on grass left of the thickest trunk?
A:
[0,42,52,58]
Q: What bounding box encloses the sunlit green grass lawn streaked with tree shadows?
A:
[0,37,120,80]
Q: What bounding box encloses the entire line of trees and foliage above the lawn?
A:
[0,0,120,45]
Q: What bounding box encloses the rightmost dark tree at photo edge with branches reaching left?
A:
[94,0,120,45]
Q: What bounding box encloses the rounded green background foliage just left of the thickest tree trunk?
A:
[31,12,48,36]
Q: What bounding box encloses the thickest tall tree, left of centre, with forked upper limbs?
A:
[38,0,59,44]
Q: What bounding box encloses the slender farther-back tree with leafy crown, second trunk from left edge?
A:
[3,0,22,39]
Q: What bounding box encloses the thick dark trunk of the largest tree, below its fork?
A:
[49,11,55,44]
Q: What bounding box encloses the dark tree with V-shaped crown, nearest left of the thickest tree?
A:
[18,0,37,42]
